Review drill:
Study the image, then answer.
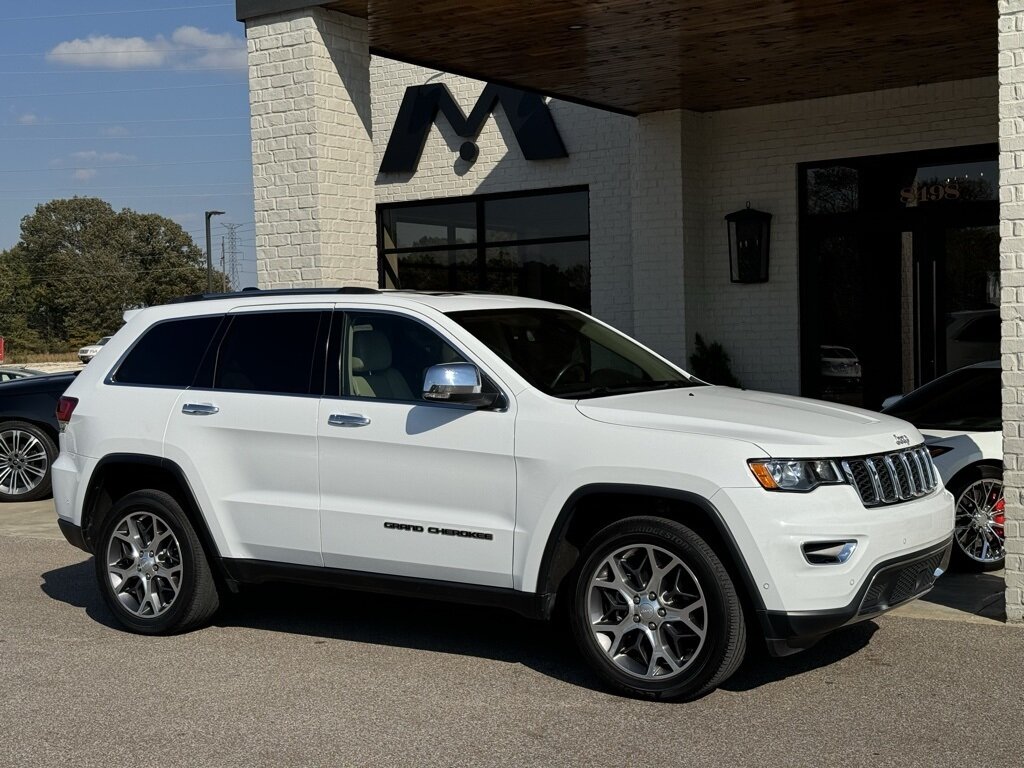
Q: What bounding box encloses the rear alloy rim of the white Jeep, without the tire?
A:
[106,511,182,618]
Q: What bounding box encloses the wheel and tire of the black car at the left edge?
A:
[0,421,57,502]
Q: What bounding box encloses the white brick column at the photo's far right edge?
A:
[998,0,1024,624]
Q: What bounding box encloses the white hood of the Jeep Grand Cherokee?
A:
[577,386,924,458]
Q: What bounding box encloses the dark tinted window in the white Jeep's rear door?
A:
[213,311,327,394]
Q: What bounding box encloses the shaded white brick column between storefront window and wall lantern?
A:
[630,110,689,368]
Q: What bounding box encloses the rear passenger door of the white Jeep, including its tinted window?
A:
[166,304,331,565]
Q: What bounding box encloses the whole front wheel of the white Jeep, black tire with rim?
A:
[569,517,746,700]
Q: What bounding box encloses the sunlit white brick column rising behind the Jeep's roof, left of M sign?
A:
[246,7,377,288]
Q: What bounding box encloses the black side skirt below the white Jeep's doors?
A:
[221,558,554,620]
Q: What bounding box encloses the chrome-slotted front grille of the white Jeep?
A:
[841,445,939,507]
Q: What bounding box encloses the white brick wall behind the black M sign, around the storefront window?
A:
[371,56,635,332]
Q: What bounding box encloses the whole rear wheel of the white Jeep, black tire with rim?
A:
[93,490,220,635]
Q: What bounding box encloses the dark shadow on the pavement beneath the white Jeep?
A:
[41,559,877,691]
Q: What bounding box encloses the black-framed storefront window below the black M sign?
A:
[378,189,590,310]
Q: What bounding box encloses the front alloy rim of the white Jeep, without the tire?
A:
[587,545,708,680]
